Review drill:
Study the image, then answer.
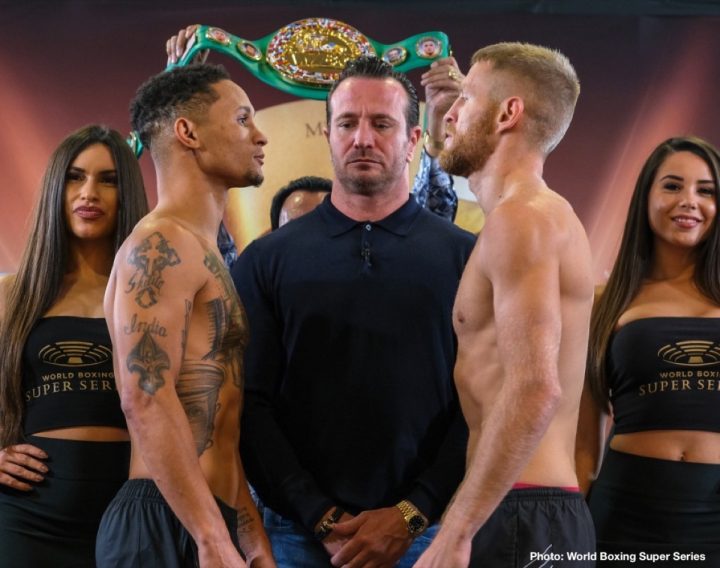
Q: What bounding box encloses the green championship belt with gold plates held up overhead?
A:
[168,18,450,99]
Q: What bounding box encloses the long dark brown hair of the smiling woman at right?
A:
[586,136,720,410]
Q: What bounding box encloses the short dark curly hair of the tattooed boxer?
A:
[130,63,230,148]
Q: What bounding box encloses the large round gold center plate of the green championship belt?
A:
[267,18,375,86]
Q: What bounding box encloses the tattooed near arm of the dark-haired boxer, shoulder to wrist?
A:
[105,221,244,567]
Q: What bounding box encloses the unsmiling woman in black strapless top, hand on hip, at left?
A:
[0,125,147,568]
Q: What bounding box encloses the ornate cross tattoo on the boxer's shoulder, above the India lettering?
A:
[125,231,180,308]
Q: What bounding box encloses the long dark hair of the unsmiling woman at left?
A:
[0,125,147,448]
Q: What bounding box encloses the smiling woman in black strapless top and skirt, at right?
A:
[576,137,720,567]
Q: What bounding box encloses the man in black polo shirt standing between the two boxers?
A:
[233,54,474,567]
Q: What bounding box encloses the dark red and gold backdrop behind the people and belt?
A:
[0,0,720,283]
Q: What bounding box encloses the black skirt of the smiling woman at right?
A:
[589,449,720,568]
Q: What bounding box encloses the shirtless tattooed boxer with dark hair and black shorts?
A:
[96,65,274,568]
